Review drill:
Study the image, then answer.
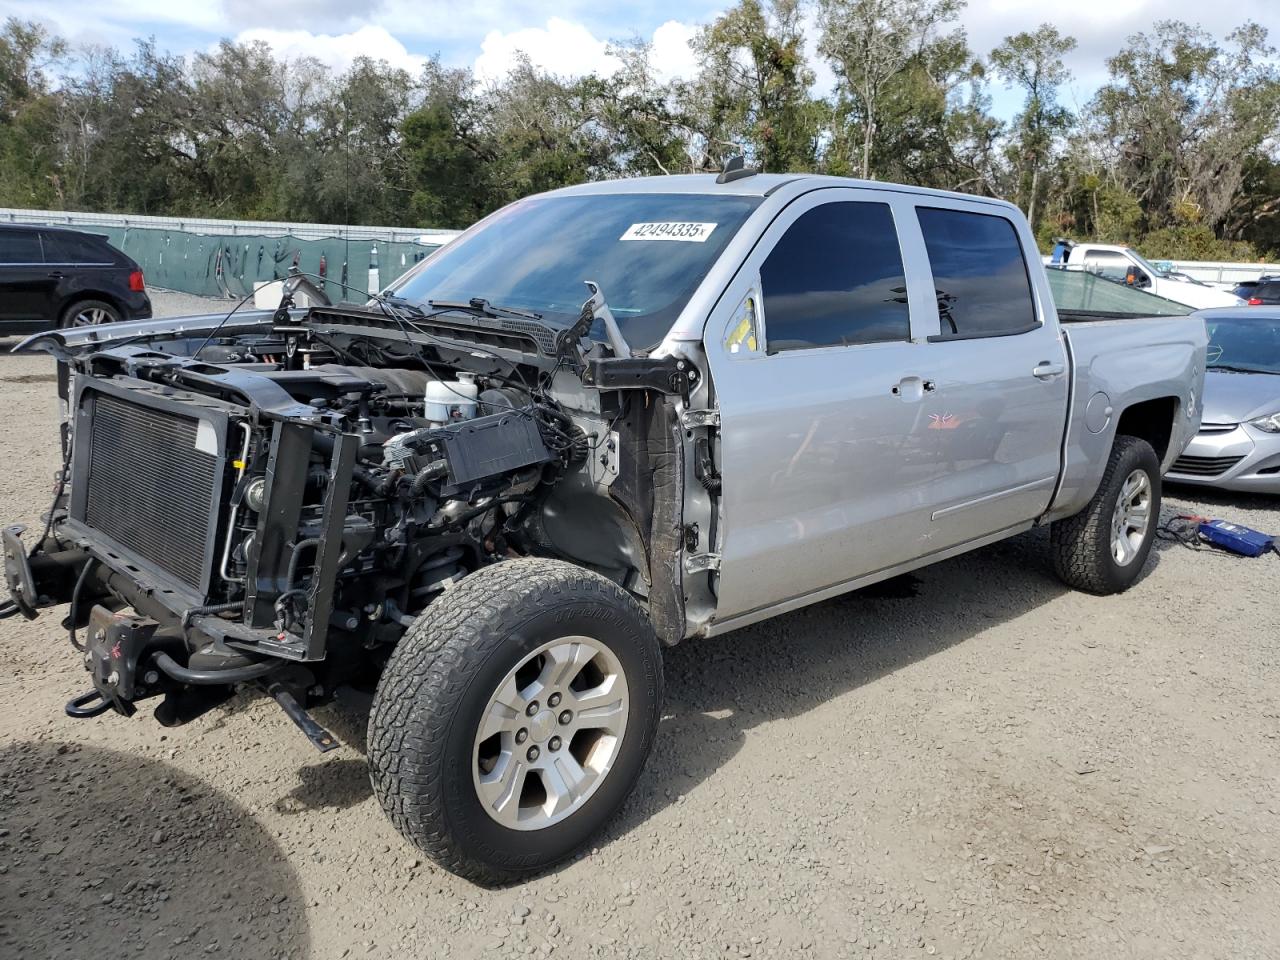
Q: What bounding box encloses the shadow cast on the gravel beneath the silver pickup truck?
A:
[288,530,1090,865]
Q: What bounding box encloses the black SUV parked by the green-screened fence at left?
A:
[0,224,151,334]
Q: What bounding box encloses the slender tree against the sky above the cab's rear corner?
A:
[991,23,1075,229]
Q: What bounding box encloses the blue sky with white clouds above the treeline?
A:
[0,0,1280,118]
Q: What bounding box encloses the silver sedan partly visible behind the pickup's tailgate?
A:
[1169,307,1280,493]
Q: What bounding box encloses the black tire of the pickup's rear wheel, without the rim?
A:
[1050,435,1161,594]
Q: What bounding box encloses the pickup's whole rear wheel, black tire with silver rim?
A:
[1050,436,1160,594]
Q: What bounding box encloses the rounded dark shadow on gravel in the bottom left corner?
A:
[0,742,308,960]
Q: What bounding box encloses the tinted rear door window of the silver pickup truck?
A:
[916,207,1036,337]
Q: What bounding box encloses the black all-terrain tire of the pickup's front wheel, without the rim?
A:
[369,559,662,886]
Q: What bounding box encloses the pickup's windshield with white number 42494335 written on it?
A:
[390,193,760,348]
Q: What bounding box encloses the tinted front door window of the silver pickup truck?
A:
[760,201,911,351]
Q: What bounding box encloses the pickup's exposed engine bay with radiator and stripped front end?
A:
[5,301,713,749]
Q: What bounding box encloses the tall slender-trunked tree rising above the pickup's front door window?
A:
[818,0,964,179]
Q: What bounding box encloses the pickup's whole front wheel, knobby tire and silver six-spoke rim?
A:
[369,559,662,883]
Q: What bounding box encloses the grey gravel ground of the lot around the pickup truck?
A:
[0,294,1280,960]
